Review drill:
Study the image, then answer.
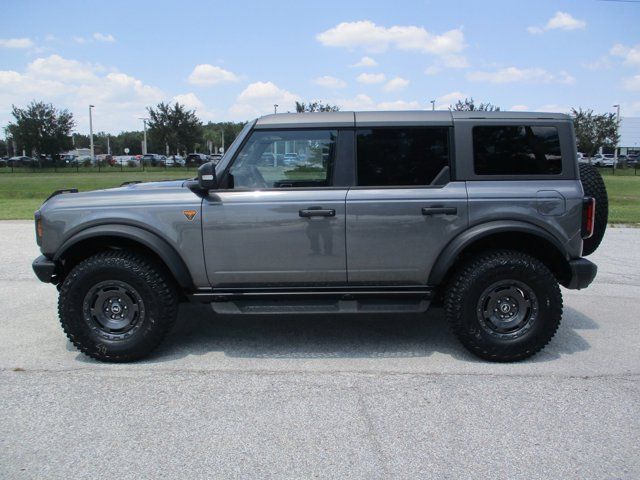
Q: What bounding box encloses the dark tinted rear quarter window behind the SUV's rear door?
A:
[473,125,562,175]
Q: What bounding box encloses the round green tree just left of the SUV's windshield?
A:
[147,102,202,152]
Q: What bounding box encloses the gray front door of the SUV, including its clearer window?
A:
[202,129,347,288]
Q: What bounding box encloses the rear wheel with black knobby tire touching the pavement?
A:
[444,250,562,362]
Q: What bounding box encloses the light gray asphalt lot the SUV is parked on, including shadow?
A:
[0,221,640,479]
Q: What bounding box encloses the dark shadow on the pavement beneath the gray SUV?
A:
[119,304,599,363]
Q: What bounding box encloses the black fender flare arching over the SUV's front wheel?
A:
[53,224,194,289]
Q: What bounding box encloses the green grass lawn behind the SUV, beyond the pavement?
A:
[0,169,640,225]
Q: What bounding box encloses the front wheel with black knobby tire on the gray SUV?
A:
[58,250,178,362]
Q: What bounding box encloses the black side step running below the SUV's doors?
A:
[190,286,433,315]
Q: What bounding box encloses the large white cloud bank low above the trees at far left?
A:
[0,55,165,132]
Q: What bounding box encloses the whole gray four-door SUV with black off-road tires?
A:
[33,111,607,362]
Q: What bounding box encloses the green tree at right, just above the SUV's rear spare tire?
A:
[571,107,620,157]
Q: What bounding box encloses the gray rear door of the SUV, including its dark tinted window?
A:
[346,117,468,285]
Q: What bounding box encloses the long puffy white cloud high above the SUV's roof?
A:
[316,20,466,55]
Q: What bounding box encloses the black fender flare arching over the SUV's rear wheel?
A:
[428,220,569,285]
